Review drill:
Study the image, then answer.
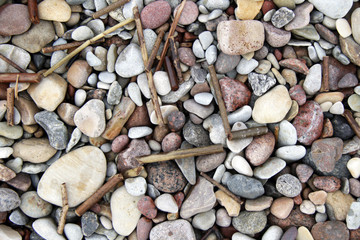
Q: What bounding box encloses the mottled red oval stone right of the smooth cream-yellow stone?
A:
[293,101,324,145]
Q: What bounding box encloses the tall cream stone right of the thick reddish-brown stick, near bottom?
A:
[110,186,141,236]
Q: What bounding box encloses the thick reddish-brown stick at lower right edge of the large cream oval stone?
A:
[75,173,124,217]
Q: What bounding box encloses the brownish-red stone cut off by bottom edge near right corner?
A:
[311,221,350,240]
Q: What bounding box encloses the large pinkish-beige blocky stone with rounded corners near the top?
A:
[217,20,265,55]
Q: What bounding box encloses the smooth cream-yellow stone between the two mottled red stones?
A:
[252,85,291,123]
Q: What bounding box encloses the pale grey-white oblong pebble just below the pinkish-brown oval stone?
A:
[254,157,286,179]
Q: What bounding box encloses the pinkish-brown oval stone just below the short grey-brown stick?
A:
[245,131,275,166]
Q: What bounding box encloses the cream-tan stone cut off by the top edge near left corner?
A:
[38,0,71,22]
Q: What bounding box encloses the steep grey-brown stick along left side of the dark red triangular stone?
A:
[209,65,233,140]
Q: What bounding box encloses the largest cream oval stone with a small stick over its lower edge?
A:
[37,146,106,207]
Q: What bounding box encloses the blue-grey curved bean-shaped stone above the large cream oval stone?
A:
[35,111,68,150]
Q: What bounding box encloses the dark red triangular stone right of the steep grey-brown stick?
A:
[219,77,251,112]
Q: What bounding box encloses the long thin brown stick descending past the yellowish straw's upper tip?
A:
[133,6,165,126]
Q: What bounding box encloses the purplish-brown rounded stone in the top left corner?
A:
[0,4,31,36]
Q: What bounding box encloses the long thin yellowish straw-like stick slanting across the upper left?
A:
[43,18,134,77]
